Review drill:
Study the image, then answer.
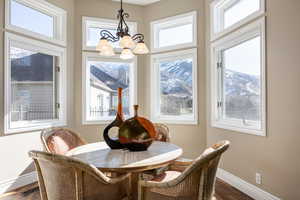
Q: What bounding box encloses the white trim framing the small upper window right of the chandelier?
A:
[150,11,198,53]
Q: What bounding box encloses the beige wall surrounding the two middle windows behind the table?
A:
[75,0,206,158]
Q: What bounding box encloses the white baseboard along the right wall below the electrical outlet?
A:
[217,168,281,200]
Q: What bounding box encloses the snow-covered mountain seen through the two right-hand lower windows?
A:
[160,60,260,96]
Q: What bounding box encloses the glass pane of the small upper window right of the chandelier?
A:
[159,24,193,47]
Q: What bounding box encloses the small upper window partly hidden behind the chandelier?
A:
[82,17,137,50]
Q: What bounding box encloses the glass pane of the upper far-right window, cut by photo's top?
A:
[224,0,260,28]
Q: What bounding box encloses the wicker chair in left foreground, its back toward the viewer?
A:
[29,151,130,200]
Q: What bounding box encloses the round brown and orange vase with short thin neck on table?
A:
[119,105,156,151]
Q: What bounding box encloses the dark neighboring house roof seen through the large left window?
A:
[11,53,54,81]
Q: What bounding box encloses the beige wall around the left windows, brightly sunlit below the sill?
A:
[0,0,74,183]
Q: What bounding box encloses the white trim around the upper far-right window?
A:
[210,0,266,41]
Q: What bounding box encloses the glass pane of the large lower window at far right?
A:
[223,37,262,126]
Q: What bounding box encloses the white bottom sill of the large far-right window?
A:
[211,122,266,137]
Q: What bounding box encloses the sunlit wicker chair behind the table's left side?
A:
[41,128,86,155]
